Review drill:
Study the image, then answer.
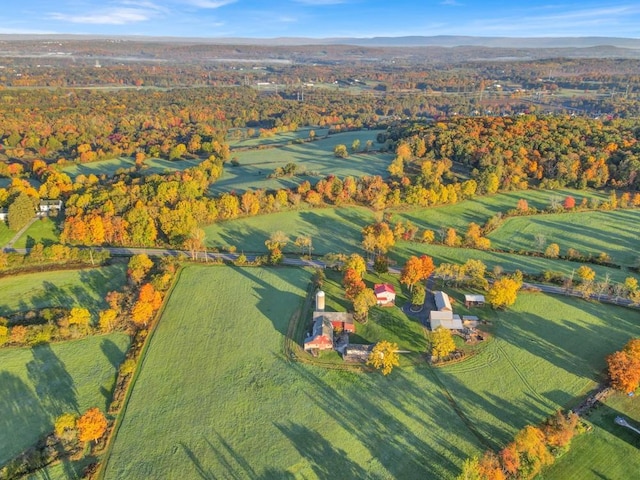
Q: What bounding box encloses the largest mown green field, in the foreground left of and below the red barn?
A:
[105,266,480,479]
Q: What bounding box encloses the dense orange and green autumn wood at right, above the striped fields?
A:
[389,115,640,193]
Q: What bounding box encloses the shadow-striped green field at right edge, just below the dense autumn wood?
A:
[489,209,640,266]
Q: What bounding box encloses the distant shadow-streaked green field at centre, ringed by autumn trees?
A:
[210,130,393,194]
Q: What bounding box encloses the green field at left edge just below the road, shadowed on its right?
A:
[0,264,126,319]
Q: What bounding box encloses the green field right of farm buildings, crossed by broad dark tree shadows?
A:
[437,293,640,450]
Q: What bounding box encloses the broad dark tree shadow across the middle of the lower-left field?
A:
[27,344,80,417]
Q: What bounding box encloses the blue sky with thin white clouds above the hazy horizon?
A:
[0,0,640,38]
